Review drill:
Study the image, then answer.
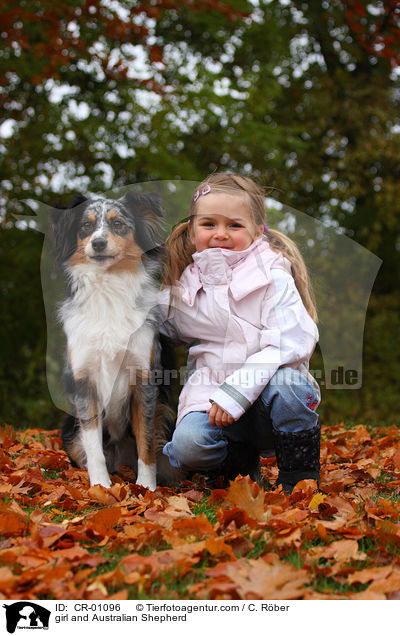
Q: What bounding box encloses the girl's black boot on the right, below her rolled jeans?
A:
[274,422,321,494]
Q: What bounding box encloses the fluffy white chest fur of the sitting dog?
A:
[60,265,157,416]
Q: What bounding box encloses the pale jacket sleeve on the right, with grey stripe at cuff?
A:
[210,268,318,420]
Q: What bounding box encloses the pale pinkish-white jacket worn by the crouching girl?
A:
[160,237,319,424]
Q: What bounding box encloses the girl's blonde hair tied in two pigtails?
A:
[163,173,318,322]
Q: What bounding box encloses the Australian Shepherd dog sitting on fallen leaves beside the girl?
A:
[52,192,178,490]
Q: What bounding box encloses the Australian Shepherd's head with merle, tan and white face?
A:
[52,192,163,271]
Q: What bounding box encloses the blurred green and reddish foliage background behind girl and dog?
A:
[0,0,400,428]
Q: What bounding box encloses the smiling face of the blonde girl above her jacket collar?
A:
[190,192,264,252]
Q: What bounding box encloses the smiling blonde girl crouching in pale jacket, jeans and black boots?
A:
[161,173,320,493]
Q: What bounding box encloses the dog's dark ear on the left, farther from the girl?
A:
[50,194,87,266]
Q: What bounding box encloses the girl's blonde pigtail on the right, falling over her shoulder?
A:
[264,228,318,322]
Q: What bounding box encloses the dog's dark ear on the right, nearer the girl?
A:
[119,192,164,252]
